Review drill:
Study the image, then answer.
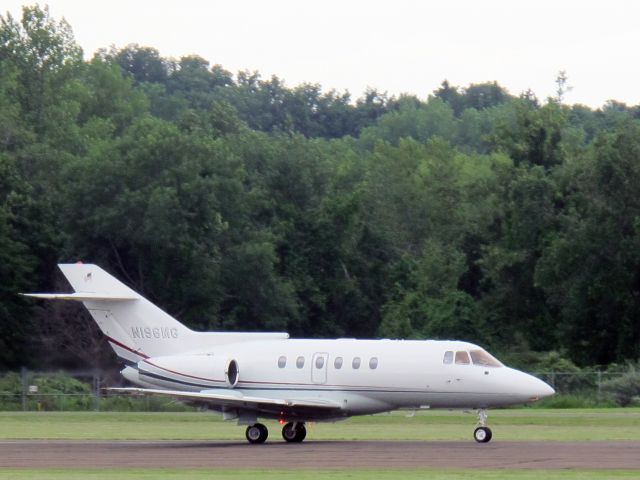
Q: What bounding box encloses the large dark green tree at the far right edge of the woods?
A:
[536,124,640,364]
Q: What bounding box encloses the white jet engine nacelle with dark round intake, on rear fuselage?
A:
[138,354,240,388]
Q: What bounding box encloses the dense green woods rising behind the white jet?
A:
[0,7,640,368]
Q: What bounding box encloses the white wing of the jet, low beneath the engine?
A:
[107,387,342,413]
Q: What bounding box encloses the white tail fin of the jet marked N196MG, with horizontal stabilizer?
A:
[28,263,288,362]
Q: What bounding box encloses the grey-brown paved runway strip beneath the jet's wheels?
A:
[0,440,640,469]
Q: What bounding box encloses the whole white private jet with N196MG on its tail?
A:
[27,263,554,444]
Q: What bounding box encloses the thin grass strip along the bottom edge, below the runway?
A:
[0,469,640,480]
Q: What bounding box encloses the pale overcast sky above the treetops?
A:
[0,0,640,107]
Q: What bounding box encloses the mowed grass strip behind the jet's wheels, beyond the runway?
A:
[0,408,640,441]
